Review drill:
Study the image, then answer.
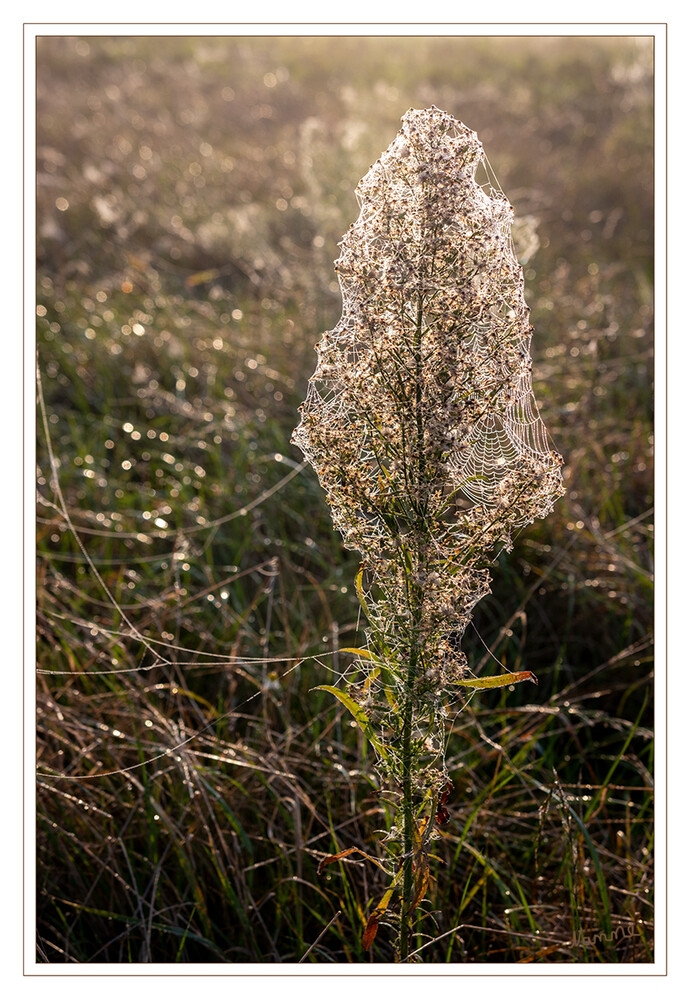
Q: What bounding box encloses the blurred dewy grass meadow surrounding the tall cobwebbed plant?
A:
[36,37,654,964]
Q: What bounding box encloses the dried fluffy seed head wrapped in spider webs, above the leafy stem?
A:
[293,107,563,696]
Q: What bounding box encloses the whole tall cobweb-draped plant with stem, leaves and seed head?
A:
[293,108,563,961]
